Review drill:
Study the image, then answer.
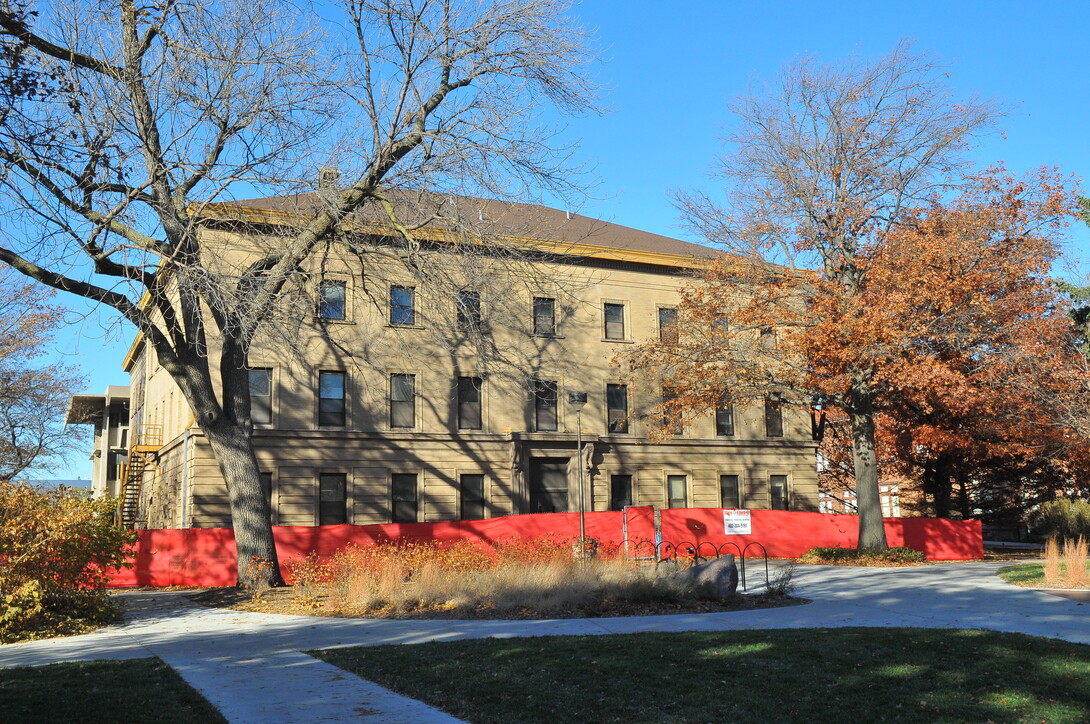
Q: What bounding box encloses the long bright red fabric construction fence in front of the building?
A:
[106,507,984,588]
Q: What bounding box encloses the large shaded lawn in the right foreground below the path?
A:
[313,628,1090,724]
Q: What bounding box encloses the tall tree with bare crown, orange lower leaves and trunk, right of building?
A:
[630,45,1090,550]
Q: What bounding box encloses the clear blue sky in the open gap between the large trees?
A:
[42,0,1090,478]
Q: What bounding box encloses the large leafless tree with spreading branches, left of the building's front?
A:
[0,0,594,583]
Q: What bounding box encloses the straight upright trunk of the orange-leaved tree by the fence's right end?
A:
[849,377,888,551]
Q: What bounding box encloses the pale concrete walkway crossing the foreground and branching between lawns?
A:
[0,563,1090,724]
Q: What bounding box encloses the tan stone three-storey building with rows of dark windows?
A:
[70,194,819,528]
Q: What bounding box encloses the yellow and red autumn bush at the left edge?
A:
[0,482,136,641]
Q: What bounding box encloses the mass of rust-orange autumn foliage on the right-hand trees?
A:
[629,169,1090,515]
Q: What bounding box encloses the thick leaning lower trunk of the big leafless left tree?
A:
[202,418,283,587]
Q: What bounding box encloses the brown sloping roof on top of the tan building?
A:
[217,191,722,260]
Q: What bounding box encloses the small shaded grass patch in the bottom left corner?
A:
[0,659,227,723]
